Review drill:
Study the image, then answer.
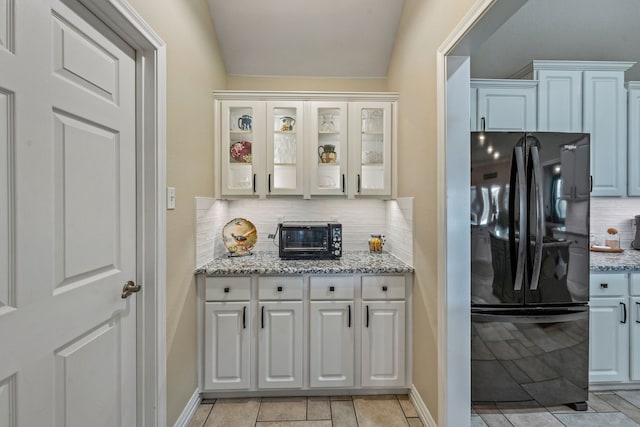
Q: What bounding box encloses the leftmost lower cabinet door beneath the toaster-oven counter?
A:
[204,301,251,390]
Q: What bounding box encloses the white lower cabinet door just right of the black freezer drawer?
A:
[589,297,629,383]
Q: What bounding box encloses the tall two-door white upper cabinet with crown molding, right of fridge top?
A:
[519,61,634,196]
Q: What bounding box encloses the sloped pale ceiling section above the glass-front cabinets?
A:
[208,0,404,78]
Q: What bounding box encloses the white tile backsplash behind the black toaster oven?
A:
[195,197,413,268]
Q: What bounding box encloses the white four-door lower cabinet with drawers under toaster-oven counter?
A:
[198,274,412,395]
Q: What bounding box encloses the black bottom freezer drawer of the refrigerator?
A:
[471,307,589,406]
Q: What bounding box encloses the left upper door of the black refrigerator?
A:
[471,132,527,305]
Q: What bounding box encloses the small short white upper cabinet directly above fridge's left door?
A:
[471,79,537,131]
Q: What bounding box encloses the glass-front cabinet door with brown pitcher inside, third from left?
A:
[307,101,348,195]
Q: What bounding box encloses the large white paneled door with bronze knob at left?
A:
[0,0,136,426]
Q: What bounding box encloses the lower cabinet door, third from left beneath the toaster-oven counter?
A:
[309,301,355,387]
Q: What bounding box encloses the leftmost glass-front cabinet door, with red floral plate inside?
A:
[220,101,266,196]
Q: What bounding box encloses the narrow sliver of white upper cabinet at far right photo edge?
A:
[627,82,640,196]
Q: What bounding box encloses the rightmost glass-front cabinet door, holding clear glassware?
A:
[349,102,392,196]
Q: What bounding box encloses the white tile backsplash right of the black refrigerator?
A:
[590,197,640,249]
